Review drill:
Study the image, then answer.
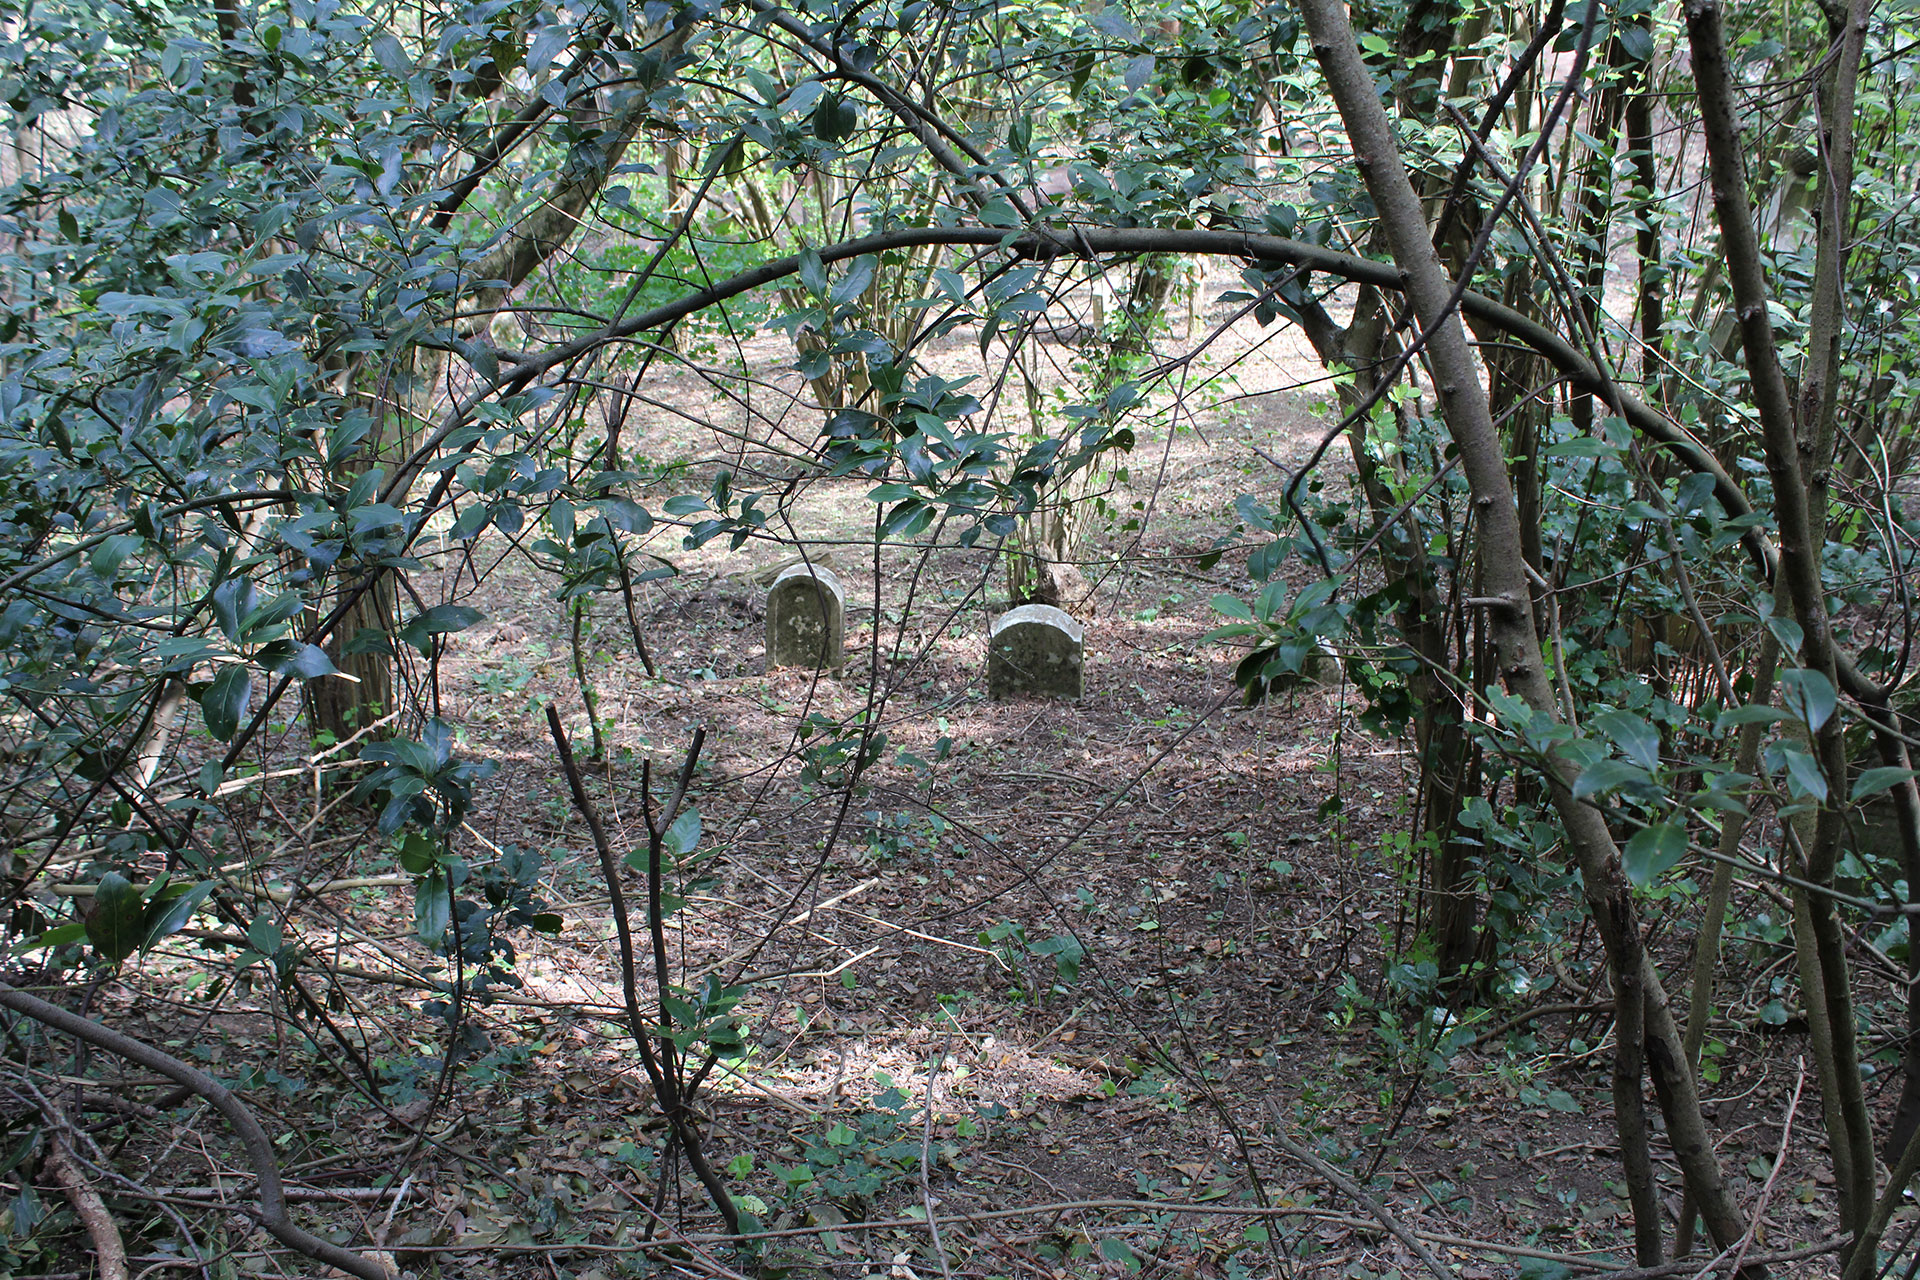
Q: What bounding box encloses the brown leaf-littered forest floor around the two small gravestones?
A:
[33,280,1905,1280]
